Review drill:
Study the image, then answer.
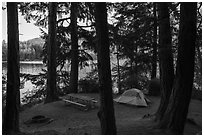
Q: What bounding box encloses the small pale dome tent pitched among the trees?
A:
[114,88,150,107]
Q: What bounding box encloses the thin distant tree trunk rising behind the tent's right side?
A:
[151,2,157,79]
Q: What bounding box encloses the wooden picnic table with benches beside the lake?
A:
[62,94,97,111]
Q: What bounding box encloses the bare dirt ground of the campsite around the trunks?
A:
[20,94,202,135]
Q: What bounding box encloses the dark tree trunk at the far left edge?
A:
[2,2,20,134]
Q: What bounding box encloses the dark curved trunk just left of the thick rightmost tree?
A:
[156,2,174,120]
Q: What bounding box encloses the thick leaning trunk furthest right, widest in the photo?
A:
[161,2,197,134]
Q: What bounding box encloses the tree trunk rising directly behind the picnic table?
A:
[70,2,79,93]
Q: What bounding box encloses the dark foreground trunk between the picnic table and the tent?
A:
[95,3,116,135]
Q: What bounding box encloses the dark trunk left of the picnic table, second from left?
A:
[45,2,58,103]
